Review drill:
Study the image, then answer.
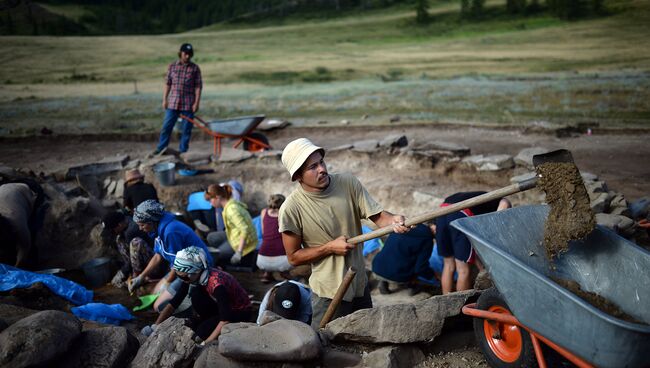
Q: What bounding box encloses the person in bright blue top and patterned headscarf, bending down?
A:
[128,199,212,307]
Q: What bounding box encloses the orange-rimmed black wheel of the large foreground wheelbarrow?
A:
[474,288,537,368]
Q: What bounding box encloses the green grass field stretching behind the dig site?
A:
[0,0,650,135]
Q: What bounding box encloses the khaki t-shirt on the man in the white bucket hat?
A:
[279,174,383,301]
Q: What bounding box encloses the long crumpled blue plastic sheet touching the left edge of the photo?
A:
[0,263,93,305]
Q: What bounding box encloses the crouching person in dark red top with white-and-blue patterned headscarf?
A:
[142,246,251,343]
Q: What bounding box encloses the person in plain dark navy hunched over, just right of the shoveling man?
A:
[372,224,436,295]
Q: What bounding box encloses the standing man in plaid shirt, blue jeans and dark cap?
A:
[154,43,203,154]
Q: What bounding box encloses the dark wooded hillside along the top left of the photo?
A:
[0,0,414,35]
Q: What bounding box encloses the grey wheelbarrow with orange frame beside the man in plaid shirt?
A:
[181,115,271,156]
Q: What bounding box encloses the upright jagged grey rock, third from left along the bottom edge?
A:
[131,317,198,368]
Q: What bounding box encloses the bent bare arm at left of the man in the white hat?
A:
[282,231,355,266]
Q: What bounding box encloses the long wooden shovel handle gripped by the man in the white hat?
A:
[347,176,537,244]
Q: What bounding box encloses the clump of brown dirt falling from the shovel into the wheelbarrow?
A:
[537,162,596,260]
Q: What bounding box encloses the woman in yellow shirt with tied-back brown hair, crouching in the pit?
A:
[205,184,257,266]
